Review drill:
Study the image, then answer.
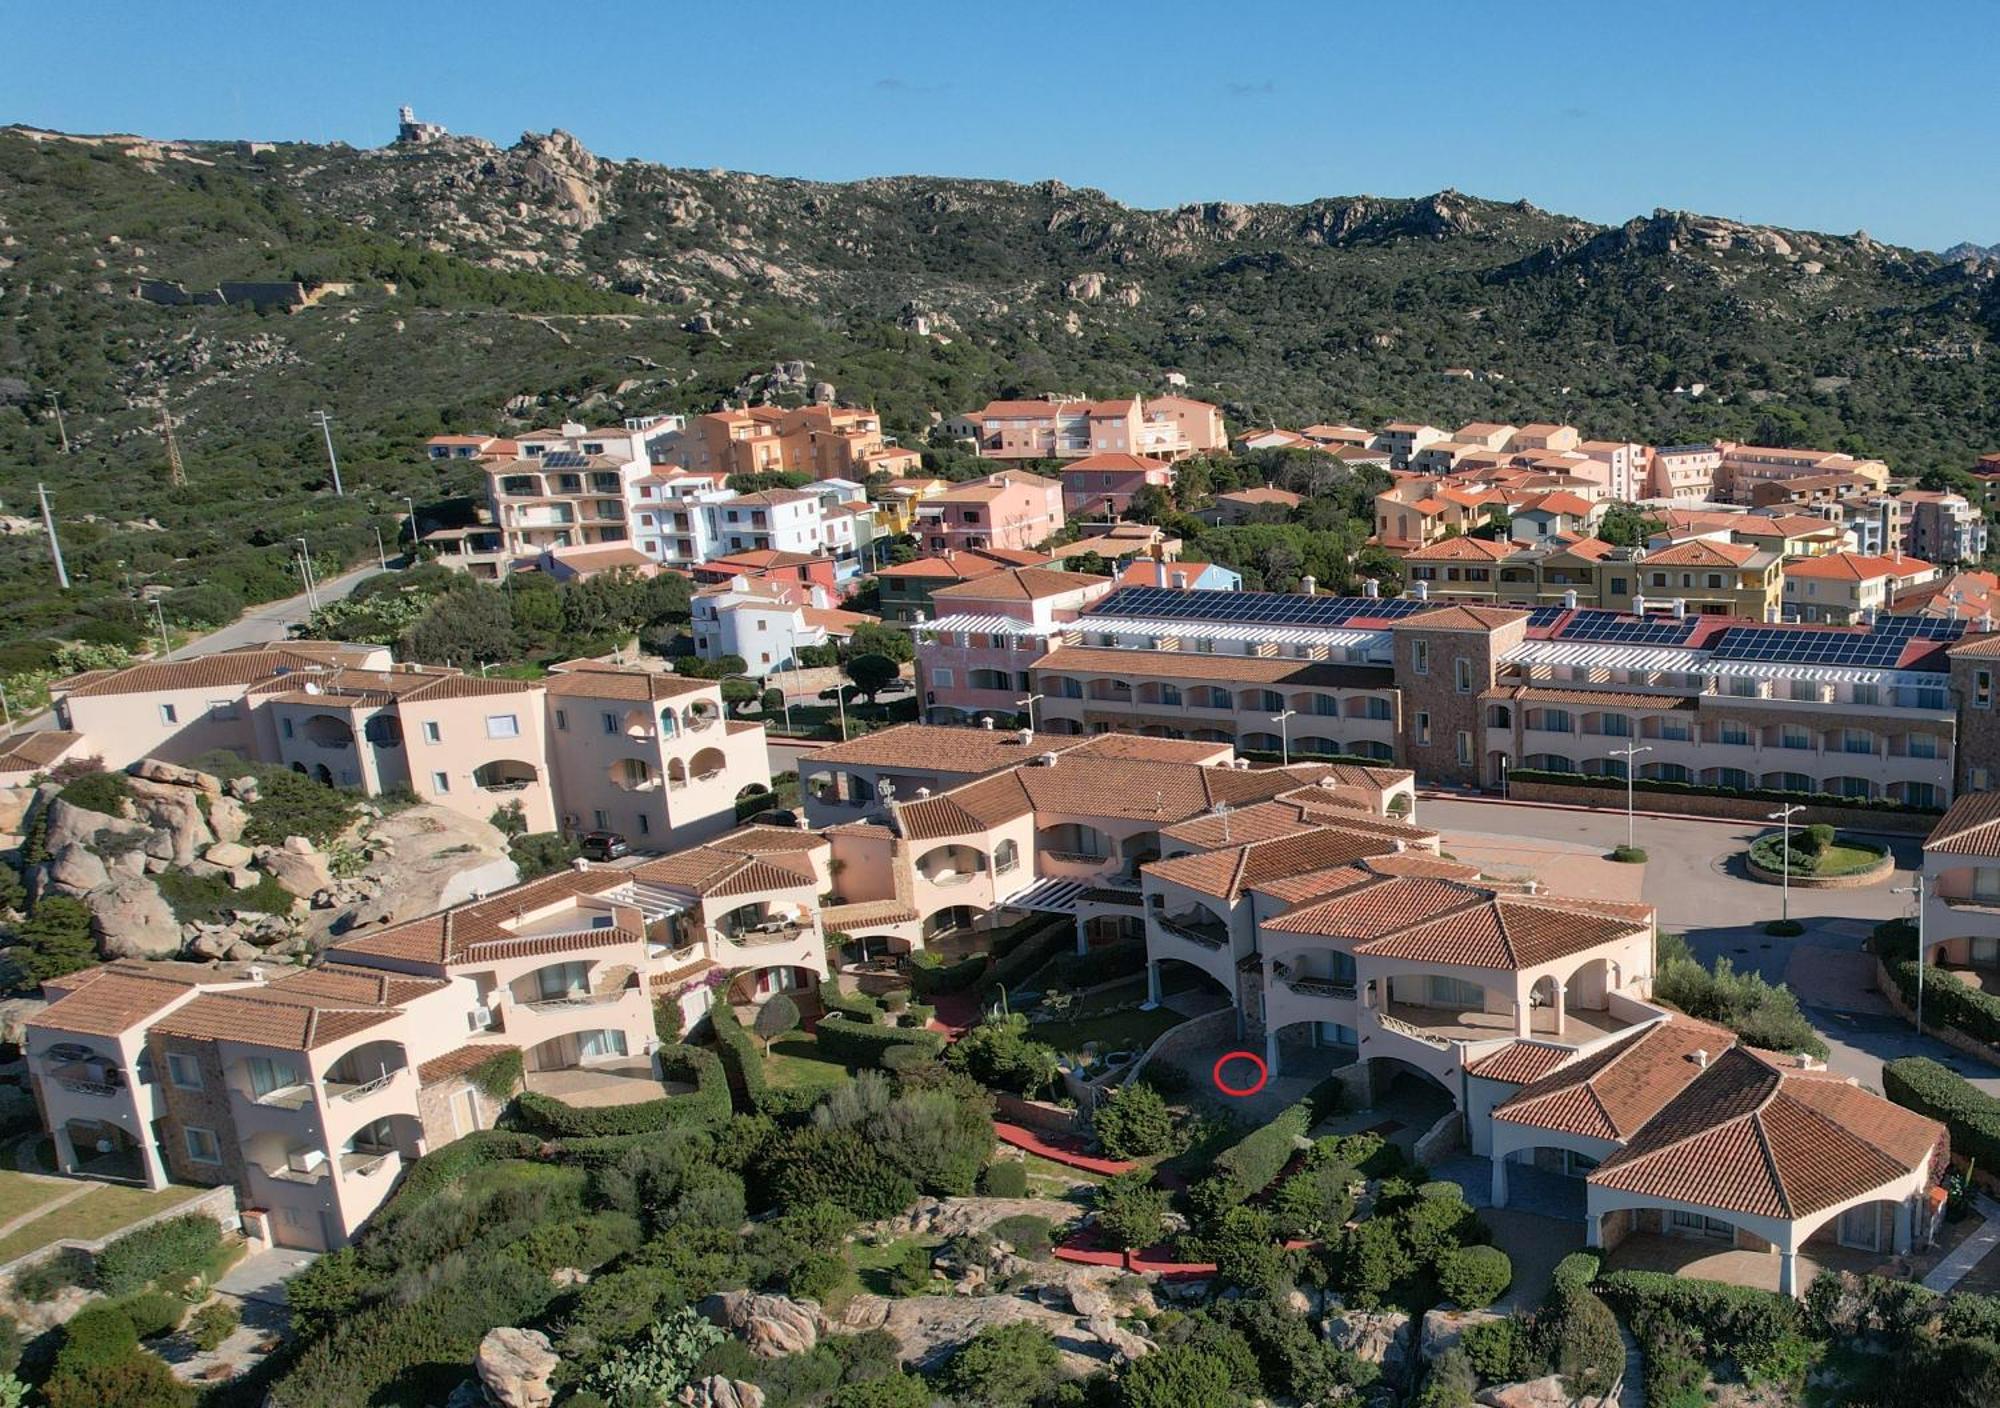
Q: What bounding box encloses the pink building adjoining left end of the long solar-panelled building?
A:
[916,568,1116,724]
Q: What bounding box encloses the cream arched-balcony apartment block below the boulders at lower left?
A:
[24,828,830,1250]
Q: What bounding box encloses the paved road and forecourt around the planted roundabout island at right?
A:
[1416,798,2000,1096]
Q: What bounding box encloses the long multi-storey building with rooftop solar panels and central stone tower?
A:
[980,588,1968,806]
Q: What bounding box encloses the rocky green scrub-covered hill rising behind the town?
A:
[0,118,2000,648]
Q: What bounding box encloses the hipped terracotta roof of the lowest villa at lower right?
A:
[1590,1048,1944,1220]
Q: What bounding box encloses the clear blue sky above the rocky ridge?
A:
[15,0,2000,248]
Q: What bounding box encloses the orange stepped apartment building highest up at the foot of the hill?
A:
[662,406,924,480]
